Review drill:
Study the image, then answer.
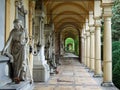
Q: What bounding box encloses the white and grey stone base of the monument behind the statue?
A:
[33,54,50,82]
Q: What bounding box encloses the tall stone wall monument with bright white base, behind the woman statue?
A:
[33,10,50,82]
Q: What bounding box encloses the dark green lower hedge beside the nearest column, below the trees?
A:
[112,41,120,89]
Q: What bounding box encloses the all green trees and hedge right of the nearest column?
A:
[112,0,120,89]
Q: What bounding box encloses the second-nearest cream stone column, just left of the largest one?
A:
[94,17,102,77]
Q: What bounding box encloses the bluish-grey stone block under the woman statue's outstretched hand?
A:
[0,55,12,88]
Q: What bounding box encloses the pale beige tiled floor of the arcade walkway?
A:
[34,54,118,90]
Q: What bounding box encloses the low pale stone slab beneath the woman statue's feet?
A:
[0,81,33,90]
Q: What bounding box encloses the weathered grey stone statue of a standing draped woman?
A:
[2,19,28,83]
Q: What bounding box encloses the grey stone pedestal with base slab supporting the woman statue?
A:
[0,56,33,90]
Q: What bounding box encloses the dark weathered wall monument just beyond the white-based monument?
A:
[44,24,57,74]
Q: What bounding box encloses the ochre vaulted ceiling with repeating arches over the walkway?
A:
[44,0,94,38]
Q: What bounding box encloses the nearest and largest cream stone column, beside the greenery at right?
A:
[102,3,113,86]
